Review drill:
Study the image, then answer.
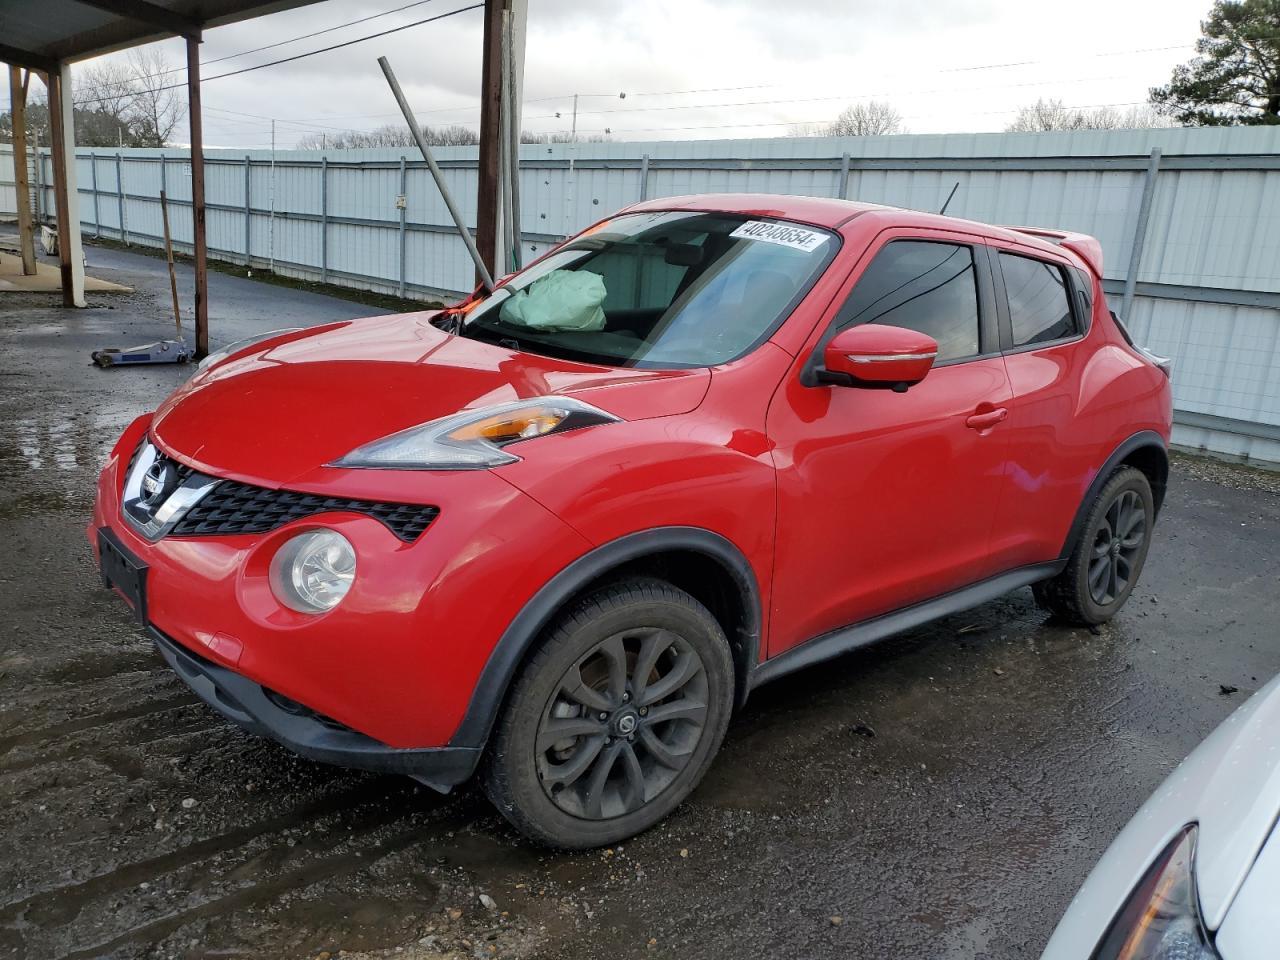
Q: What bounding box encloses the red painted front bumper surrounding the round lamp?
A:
[87,417,585,769]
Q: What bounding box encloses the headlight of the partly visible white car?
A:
[1093,826,1219,960]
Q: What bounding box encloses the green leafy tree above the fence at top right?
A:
[1151,0,1280,127]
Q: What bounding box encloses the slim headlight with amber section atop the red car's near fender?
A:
[334,397,618,470]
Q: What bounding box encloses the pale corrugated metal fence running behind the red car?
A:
[0,128,1280,462]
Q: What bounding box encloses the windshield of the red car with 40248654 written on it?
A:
[461,211,837,367]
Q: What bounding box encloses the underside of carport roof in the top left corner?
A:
[0,0,316,72]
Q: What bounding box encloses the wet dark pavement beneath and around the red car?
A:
[0,241,1280,960]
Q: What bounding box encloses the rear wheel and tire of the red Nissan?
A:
[1032,467,1156,626]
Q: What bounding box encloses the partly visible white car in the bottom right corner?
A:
[1042,677,1280,960]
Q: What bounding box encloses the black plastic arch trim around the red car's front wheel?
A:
[449,526,762,748]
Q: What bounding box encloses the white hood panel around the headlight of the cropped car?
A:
[1042,677,1280,960]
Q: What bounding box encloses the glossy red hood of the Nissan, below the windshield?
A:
[151,314,710,486]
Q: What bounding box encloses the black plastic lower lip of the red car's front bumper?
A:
[147,627,480,792]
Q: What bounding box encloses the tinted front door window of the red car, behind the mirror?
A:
[838,241,978,364]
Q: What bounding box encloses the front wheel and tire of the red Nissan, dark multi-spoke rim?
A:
[481,579,733,850]
